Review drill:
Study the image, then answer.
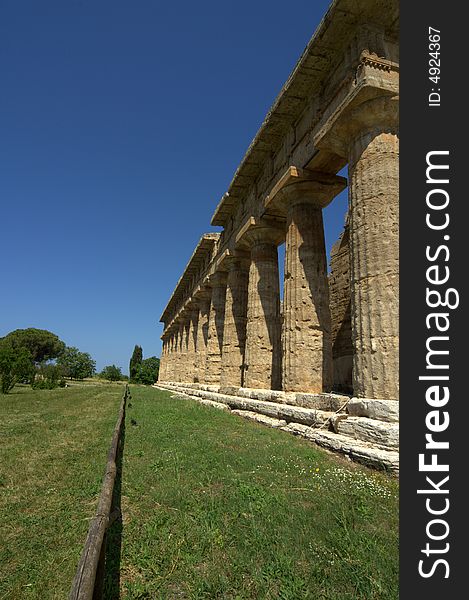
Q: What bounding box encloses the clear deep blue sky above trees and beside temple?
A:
[0,0,346,372]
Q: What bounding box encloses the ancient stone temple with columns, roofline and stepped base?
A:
[159,0,399,470]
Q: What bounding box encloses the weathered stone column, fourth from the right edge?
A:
[220,252,250,387]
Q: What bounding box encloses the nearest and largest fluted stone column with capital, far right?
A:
[321,95,399,399]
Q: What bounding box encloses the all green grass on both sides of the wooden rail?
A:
[0,385,398,600]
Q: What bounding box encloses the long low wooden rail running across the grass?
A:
[69,385,130,600]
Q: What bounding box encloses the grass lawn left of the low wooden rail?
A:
[0,384,123,600]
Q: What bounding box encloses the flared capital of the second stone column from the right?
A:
[264,165,347,215]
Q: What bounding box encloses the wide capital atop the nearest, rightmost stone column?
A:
[314,88,399,159]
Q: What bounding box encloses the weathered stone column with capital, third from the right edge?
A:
[236,217,285,390]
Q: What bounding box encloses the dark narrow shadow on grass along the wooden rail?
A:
[102,419,125,600]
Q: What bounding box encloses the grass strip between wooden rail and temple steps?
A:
[120,387,398,600]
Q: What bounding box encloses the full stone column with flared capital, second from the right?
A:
[265,166,346,393]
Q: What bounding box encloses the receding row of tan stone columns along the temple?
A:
[160,98,398,399]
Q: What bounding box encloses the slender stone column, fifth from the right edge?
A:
[205,272,226,385]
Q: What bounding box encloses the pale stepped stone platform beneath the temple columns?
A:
[155,381,399,475]
